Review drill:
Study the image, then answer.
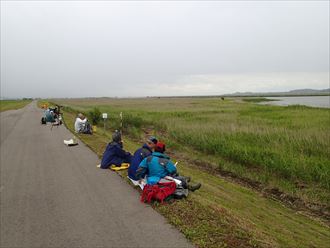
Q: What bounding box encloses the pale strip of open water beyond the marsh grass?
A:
[260,96,330,108]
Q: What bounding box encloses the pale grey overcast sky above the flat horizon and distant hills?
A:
[1,1,329,98]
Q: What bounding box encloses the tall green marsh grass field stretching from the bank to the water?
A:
[52,98,330,205]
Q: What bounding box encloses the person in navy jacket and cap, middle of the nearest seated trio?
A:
[128,136,158,181]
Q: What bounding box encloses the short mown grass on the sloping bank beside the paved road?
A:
[51,104,330,247]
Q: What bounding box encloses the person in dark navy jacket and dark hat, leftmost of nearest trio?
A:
[100,130,132,169]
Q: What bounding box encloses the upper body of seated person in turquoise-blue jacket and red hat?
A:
[136,142,176,185]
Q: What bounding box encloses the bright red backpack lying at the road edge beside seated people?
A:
[141,182,176,203]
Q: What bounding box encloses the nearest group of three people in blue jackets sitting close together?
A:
[99,131,201,198]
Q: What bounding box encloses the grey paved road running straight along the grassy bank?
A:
[0,102,191,248]
